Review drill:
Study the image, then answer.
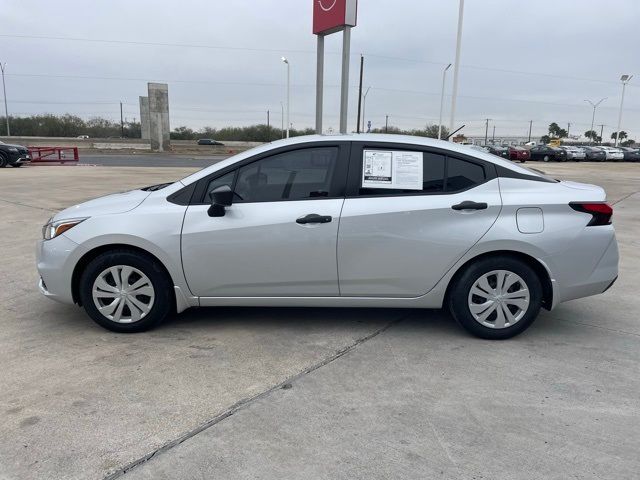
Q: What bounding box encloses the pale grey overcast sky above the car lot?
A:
[0,0,640,140]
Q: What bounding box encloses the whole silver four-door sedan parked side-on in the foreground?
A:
[37,134,618,339]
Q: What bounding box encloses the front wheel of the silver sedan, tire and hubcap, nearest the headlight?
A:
[80,250,174,333]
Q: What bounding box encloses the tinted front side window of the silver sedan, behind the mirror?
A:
[234,147,338,202]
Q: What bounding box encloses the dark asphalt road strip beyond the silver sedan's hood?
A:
[79,153,229,168]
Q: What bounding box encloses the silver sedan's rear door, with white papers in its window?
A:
[338,142,502,297]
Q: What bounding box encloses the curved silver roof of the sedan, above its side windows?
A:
[181,133,542,185]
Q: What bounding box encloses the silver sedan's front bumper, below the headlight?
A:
[36,234,83,304]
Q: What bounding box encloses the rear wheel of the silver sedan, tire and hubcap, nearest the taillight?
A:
[449,256,542,340]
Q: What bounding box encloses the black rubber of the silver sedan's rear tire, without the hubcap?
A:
[448,256,542,340]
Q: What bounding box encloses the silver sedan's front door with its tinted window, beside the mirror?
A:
[182,142,349,297]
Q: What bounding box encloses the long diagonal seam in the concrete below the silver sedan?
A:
[103,314,410,480]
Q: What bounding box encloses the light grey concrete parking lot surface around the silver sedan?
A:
[0,162,640,480]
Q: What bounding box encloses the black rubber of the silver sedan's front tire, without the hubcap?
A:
[80,249,175,333]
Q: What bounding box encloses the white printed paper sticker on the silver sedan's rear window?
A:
[362,150,423,190]
